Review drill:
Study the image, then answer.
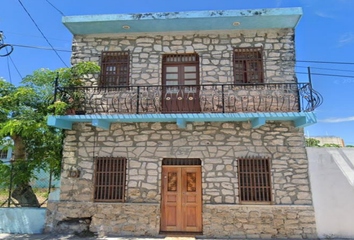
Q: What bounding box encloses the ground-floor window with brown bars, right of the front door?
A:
[238,157,272,203]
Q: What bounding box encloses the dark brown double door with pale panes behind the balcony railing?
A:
[162,53,200,113]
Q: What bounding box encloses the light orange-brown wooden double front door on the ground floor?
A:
[161,166,202,232]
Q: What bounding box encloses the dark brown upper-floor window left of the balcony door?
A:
[100,51,130,86]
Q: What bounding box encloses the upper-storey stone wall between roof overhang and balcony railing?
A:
[72,29,296,85]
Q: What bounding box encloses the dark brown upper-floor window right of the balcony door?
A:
[234,47,264,83]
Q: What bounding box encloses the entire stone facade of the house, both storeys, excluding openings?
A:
[46,25,316,238]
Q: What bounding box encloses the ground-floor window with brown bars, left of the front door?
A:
[94,157,127,202]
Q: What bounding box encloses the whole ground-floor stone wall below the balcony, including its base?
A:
[48,122,316,237]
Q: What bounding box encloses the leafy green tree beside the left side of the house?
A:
[0,63,99,207]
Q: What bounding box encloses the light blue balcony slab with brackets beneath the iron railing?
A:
[48,112,317,129]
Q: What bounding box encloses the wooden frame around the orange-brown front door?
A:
[160,165,203,234]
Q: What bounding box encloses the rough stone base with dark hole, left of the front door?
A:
[45,202,160,236]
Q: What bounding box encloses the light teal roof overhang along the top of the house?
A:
[63,7,302,35]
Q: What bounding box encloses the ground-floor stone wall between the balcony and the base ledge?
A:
[60,122,312,205]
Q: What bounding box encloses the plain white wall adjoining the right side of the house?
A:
[307,148,354,239]
